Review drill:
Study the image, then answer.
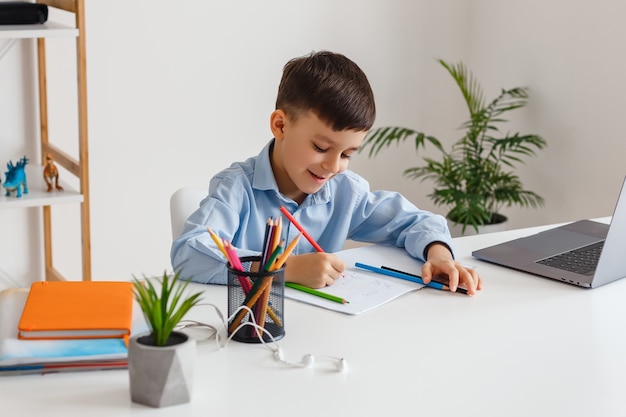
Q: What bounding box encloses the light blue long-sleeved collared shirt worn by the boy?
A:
[171,141,452,284]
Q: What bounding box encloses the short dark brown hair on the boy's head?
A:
[276,51,376,131]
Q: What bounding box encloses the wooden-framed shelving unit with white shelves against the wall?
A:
[0,0,91,281]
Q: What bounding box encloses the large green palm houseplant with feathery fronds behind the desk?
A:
[362,60,546,233]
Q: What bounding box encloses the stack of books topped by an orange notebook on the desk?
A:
[0,281,145,376]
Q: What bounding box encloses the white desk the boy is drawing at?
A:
[0,219,626,417]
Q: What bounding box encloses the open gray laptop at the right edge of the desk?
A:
[472,175,626,288]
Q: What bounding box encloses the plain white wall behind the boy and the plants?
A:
[0,0,626,282]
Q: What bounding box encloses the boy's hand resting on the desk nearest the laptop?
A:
[422,244,483,295]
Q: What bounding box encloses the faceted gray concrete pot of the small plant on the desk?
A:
[128,332,196,407]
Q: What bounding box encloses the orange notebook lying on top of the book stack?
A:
[18,281,134,339]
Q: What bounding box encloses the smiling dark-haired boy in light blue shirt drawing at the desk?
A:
[171,51,482,294]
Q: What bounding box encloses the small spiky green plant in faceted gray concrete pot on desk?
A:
[128,272,202,407]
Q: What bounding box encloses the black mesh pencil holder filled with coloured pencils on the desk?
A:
[227,256,285,343]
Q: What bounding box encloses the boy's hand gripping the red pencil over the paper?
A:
[285,252,346,288]
